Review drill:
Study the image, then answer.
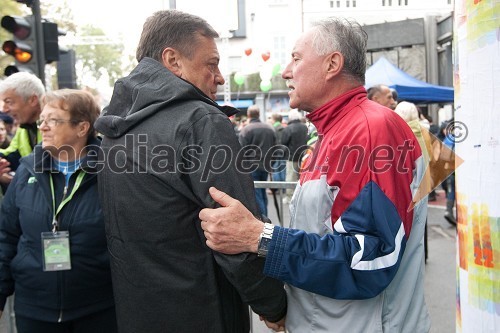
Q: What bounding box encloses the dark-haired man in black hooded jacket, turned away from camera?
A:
[96,10,287,333]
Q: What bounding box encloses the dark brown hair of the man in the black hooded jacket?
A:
[136,10,219,62]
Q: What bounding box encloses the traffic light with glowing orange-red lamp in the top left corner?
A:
[1,15,40,77]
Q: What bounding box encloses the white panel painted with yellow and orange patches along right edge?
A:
[453,0,500,333]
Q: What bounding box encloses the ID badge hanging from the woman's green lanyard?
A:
[42,231,71,272]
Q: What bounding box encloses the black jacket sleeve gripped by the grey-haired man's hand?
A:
[182,113,286,321]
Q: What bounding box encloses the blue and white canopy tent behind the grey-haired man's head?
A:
[365,57,454,104]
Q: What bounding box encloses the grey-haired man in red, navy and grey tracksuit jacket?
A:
[200,17,430,333]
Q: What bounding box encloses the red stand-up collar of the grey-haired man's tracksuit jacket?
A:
[306,86,366,135]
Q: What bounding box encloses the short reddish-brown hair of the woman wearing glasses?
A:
[45,89,101,138]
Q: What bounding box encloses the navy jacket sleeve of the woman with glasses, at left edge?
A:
[0,170,21,309]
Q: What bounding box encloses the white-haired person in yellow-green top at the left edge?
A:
[0,72,45,186]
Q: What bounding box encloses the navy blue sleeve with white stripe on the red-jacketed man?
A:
[264,182,406,299]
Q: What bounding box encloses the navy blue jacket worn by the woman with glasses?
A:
[0,139,114,322]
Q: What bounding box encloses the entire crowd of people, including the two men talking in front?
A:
[0,10,451,333]
